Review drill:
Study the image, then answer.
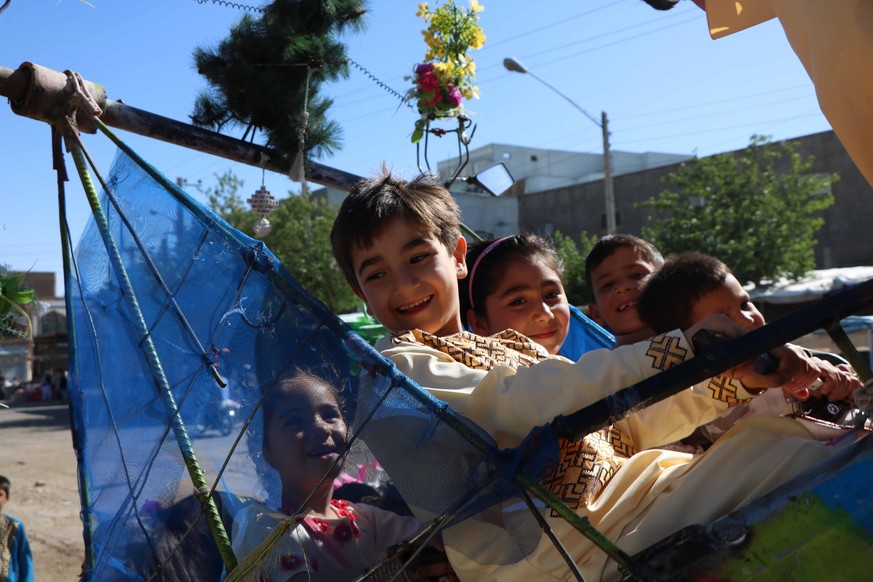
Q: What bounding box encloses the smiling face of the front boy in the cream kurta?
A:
[352,219,467,336]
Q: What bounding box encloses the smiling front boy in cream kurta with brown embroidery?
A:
[331,172,844,580]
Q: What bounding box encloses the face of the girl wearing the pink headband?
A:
[467,259,570,354]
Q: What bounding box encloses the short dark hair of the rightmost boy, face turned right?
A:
[637,252,731,333]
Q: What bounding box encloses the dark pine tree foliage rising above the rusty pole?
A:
[191,0,364,156]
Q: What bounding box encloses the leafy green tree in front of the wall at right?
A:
[641,136,839,284]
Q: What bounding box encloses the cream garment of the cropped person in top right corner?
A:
[706,0,873,184]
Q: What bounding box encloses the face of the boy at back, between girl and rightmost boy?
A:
[590,246,656,335]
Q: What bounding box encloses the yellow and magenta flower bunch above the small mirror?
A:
[406,0,485,143]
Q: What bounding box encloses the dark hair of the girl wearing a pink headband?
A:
[458,233,564,326]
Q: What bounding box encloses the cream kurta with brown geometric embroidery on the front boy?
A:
[374,332,829,581]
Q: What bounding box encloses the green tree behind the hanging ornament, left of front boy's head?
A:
[207,171,360,313]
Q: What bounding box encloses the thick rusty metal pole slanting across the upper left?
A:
[0,62,361,191]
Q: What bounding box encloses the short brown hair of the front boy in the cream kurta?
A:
[330,166,461,289]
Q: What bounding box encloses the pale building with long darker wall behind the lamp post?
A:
[313,131,873,269]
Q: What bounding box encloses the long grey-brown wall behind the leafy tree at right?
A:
[518,131,873,269]
